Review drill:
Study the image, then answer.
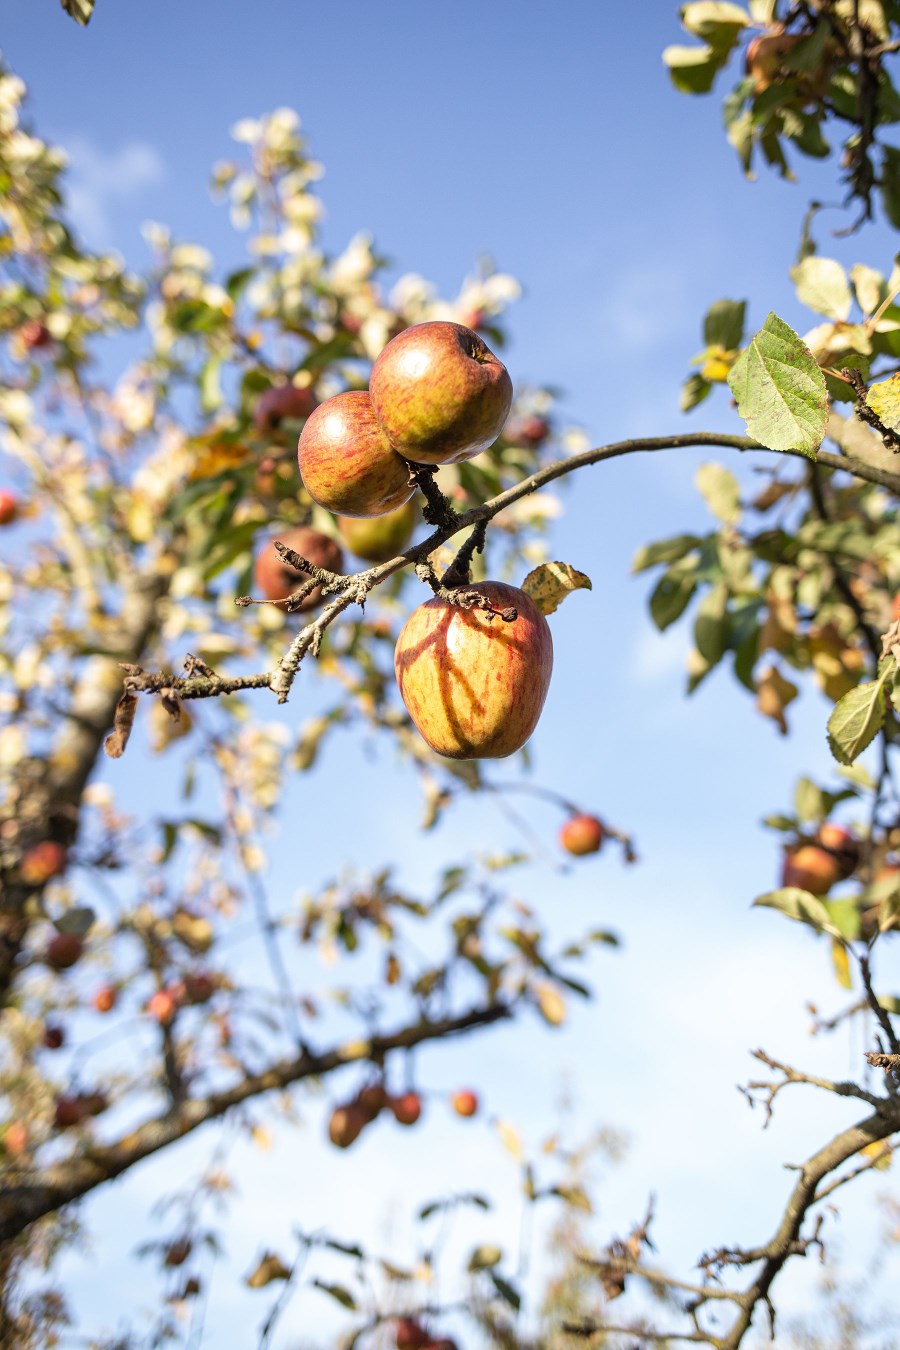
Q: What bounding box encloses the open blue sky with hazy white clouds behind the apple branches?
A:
[3,0,900,1346]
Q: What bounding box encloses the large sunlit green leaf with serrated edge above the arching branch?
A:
[729,313,828,459]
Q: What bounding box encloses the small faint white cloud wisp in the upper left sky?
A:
[65,135,165,246]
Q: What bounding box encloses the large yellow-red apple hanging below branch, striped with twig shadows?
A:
[394,582,553,759]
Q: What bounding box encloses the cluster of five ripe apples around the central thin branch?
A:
[255,321,553,759]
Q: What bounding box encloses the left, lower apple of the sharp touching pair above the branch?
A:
[297,390,416,518]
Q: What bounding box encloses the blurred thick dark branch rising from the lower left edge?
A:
[0,1003,513,1242]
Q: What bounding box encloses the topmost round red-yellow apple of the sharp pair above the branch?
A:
[368,321,513,464]
